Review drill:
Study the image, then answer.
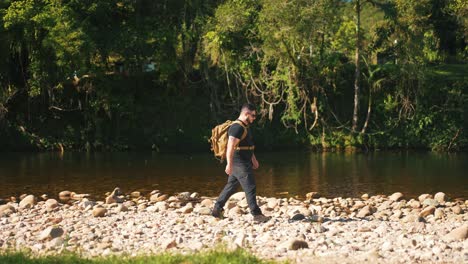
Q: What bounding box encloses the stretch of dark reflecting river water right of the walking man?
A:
[259,153,468,198]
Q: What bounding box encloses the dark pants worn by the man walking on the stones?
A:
[214,163,262,215]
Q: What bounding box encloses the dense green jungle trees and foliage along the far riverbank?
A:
[0,0,468,151]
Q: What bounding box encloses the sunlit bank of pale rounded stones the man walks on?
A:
[0,188,468,263]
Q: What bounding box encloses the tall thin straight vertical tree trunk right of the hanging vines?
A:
[352,0,361,132]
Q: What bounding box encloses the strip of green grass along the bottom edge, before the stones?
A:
[0,250,273,264]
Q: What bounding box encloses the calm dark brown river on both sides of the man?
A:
[0,152,468,199]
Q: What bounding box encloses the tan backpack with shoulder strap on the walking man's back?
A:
[210,120,248,162]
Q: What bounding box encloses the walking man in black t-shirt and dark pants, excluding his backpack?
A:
[212,104,270,222]
